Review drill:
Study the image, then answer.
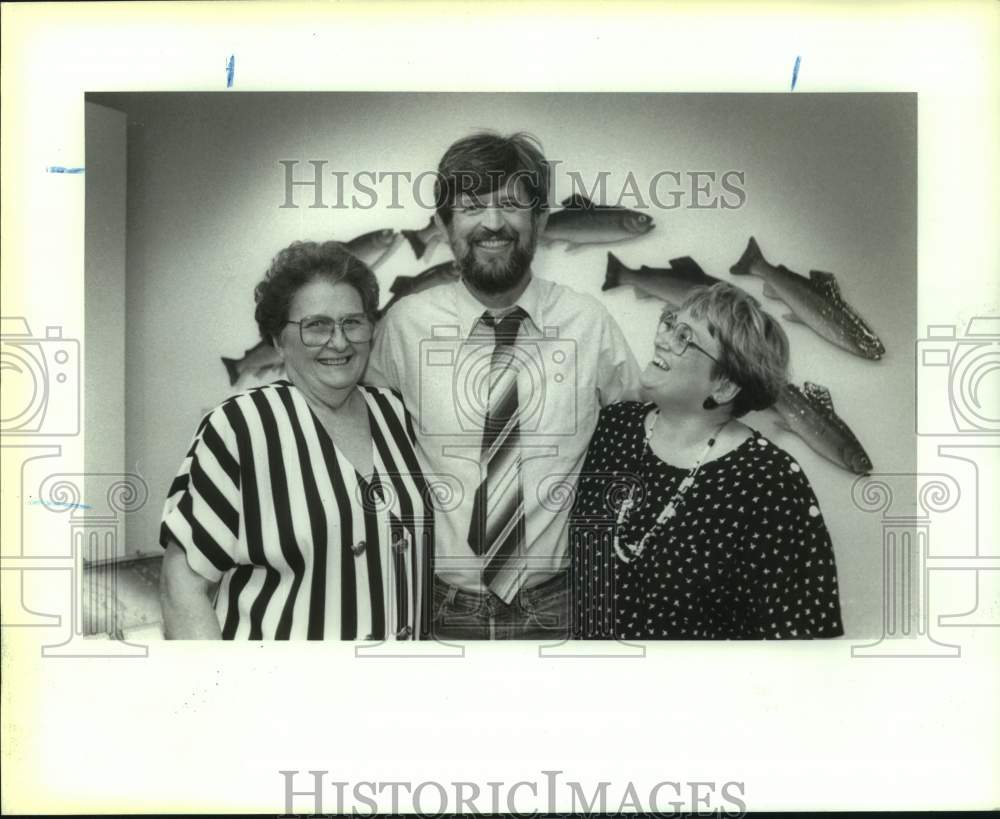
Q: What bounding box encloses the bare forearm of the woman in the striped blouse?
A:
[160,541,222,640]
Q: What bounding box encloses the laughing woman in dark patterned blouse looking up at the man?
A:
[570,282,843,640]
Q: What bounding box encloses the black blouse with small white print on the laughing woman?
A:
[570,402,844,640]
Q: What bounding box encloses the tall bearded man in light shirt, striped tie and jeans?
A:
[367,133,639,639]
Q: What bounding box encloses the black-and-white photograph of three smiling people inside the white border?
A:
[85,88,917,642]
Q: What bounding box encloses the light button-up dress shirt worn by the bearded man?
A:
[364,276,639,592]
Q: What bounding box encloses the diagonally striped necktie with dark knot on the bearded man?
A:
[469,307,527,603]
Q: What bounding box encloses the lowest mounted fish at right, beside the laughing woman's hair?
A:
[772,381,872,475]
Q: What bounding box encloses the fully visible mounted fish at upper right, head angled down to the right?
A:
[729,236,885,361]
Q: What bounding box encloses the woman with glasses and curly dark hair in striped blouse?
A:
[160,242,433,640]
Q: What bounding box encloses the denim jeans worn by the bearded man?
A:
[431,571,570,641]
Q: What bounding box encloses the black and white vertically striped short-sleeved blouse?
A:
[160,380,433,640]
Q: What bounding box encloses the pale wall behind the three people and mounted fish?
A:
[87,93,916,635]
